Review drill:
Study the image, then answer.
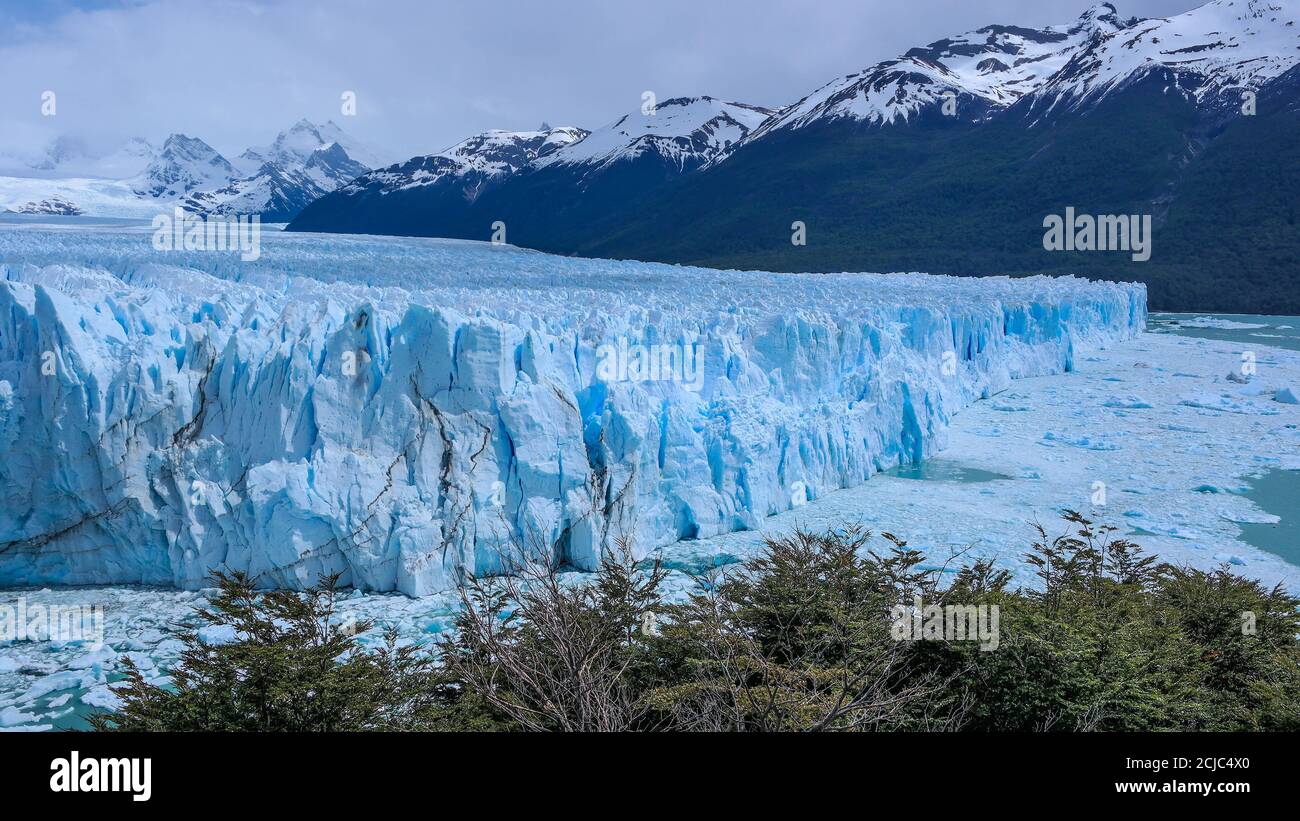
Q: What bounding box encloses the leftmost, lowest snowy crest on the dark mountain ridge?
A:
[343,126,588,199]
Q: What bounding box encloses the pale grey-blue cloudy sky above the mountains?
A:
[0,0,1199,164]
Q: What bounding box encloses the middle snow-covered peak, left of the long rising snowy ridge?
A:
[537,96,774,170]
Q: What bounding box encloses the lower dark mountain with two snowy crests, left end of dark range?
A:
[289,97,772,244]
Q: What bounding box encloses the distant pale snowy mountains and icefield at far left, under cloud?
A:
[0,120,380,222]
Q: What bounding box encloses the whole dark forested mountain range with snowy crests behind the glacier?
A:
[290,0,1300,313]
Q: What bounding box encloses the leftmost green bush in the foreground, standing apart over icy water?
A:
[92,573,491,731]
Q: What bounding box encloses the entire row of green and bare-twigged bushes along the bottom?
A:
[92,513,1300,731]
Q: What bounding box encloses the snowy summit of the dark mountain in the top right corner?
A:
[1037,0,1300,114]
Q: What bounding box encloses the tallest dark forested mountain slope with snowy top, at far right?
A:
[585,0,1300,314]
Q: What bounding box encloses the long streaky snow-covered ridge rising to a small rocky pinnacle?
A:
[751,3,1134,139]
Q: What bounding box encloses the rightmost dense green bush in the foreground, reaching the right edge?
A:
[894,511,1300,731]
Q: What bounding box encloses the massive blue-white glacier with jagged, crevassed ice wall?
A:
[0,223,1147,596]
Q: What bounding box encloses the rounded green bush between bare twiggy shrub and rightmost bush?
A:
[650,527,952,731]
